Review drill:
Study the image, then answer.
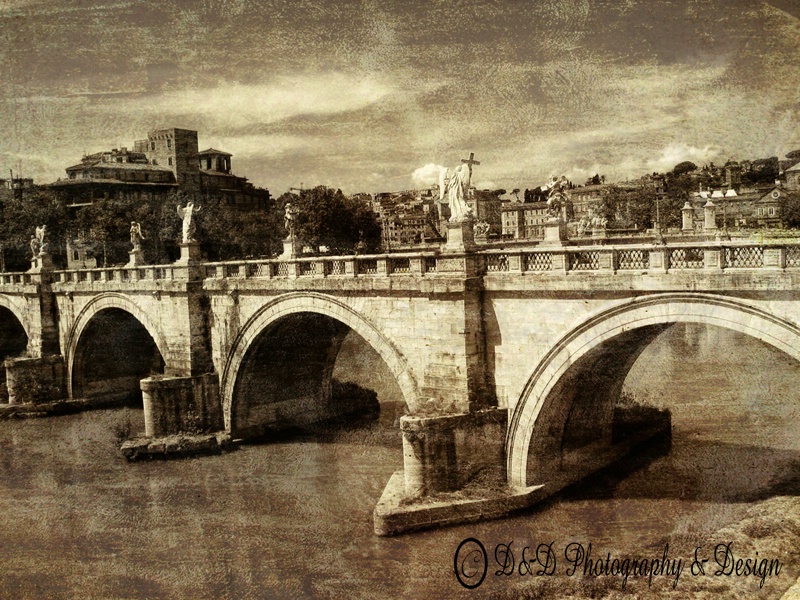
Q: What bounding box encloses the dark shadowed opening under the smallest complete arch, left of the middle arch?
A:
[72,308,164,406]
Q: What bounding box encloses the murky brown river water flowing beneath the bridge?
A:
[0,326,800,598]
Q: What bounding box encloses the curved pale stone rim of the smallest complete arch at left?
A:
[64,292,169,398]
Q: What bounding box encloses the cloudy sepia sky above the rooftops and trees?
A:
[0,0,800,195]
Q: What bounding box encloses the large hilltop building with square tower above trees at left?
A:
[49,128,270,210]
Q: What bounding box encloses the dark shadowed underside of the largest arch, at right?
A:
[526,324,670,494]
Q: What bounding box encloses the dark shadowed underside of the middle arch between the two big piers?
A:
[230,312,388,439]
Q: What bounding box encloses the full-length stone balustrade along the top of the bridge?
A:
[6,242,800,287]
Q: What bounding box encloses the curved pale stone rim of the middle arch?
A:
[221,292,417,431]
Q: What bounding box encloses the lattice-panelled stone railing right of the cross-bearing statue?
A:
[482,242,800,274]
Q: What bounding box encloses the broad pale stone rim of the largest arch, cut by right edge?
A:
[506,293,800,486]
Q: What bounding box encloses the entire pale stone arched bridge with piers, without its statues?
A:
[0,240,800,534]
